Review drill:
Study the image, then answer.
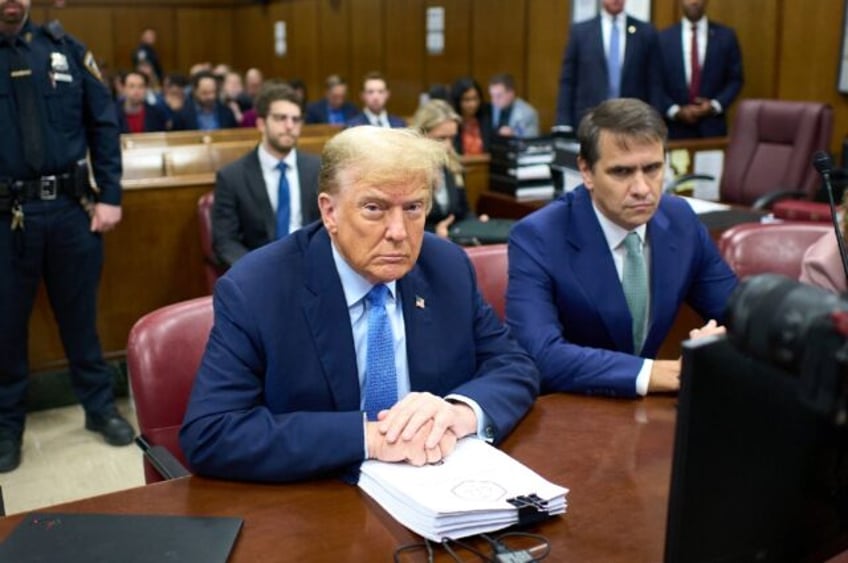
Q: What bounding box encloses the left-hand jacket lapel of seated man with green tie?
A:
[568,192,633,350]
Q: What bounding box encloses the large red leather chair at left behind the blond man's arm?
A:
[127,297,212,483]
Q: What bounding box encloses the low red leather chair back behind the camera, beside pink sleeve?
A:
[718,222,833,280]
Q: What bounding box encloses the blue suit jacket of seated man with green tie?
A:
[506,186,737,397]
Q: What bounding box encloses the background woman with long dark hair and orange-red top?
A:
[450,77,492,154]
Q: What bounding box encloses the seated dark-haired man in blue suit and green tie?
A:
[506,98,737,397]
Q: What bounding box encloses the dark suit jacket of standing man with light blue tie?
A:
[556,16,662,129]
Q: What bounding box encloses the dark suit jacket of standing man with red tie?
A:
[659,22,744,139]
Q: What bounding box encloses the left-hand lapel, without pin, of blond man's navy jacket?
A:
[303,227,359,411]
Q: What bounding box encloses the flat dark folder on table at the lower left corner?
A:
[0,512,243,563]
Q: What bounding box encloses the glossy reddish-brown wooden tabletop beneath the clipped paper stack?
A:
[0,394,675,563]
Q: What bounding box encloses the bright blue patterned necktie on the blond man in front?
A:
[365,284,397,420]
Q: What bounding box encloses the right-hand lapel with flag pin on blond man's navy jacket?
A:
[397,266,436,391]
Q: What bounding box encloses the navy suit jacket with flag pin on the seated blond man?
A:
[180,222,539,481]
